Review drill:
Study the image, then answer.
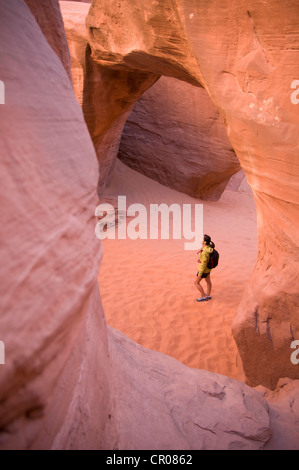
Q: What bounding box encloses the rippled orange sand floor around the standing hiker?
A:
[99,161,256,380]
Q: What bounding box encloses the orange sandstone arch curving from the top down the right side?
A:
[87,0,299,388]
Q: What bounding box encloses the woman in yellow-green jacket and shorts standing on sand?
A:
[194,235,215,302]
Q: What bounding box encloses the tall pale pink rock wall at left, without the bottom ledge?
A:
[0,0,110,449]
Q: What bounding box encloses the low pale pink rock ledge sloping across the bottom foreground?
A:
[109,327,271,450]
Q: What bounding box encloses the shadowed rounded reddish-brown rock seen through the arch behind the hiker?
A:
[119,77,240,200]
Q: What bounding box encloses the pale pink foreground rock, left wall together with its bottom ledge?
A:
[0,0,278,449]
